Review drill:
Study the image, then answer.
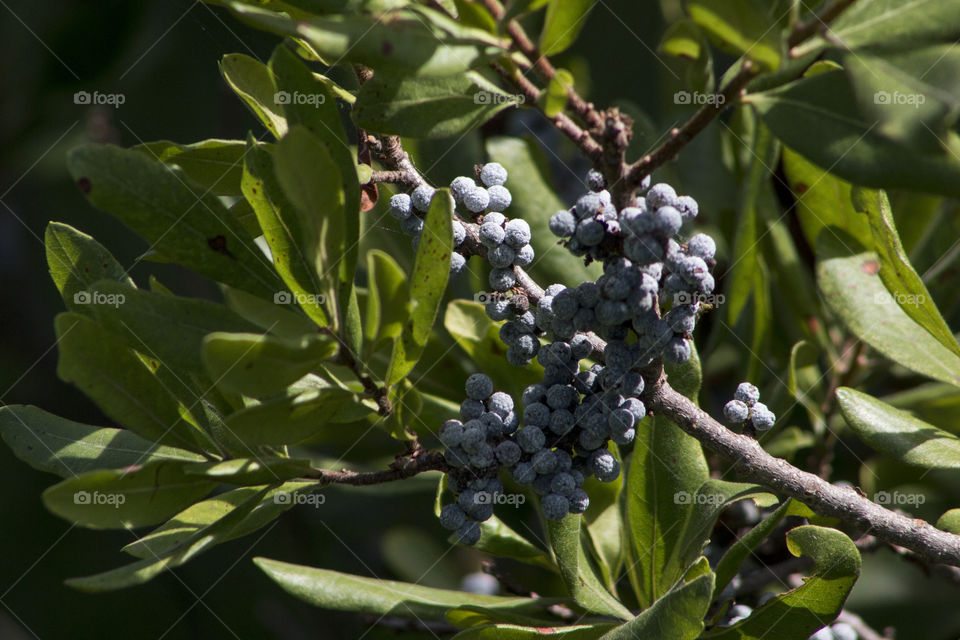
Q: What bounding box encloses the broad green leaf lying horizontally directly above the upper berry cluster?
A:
[353,71,518,138]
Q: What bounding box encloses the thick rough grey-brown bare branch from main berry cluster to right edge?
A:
[644,378,960,566]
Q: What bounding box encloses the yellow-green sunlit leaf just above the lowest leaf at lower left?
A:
[123,481,314,560]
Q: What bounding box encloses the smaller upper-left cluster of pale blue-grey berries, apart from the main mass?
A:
[390,162,534,278]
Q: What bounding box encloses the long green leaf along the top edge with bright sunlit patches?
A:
[229,2,502,76]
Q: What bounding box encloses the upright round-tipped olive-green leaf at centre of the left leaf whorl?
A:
[274,125,348,324]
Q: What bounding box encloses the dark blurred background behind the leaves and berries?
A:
[0,0,960,640]
